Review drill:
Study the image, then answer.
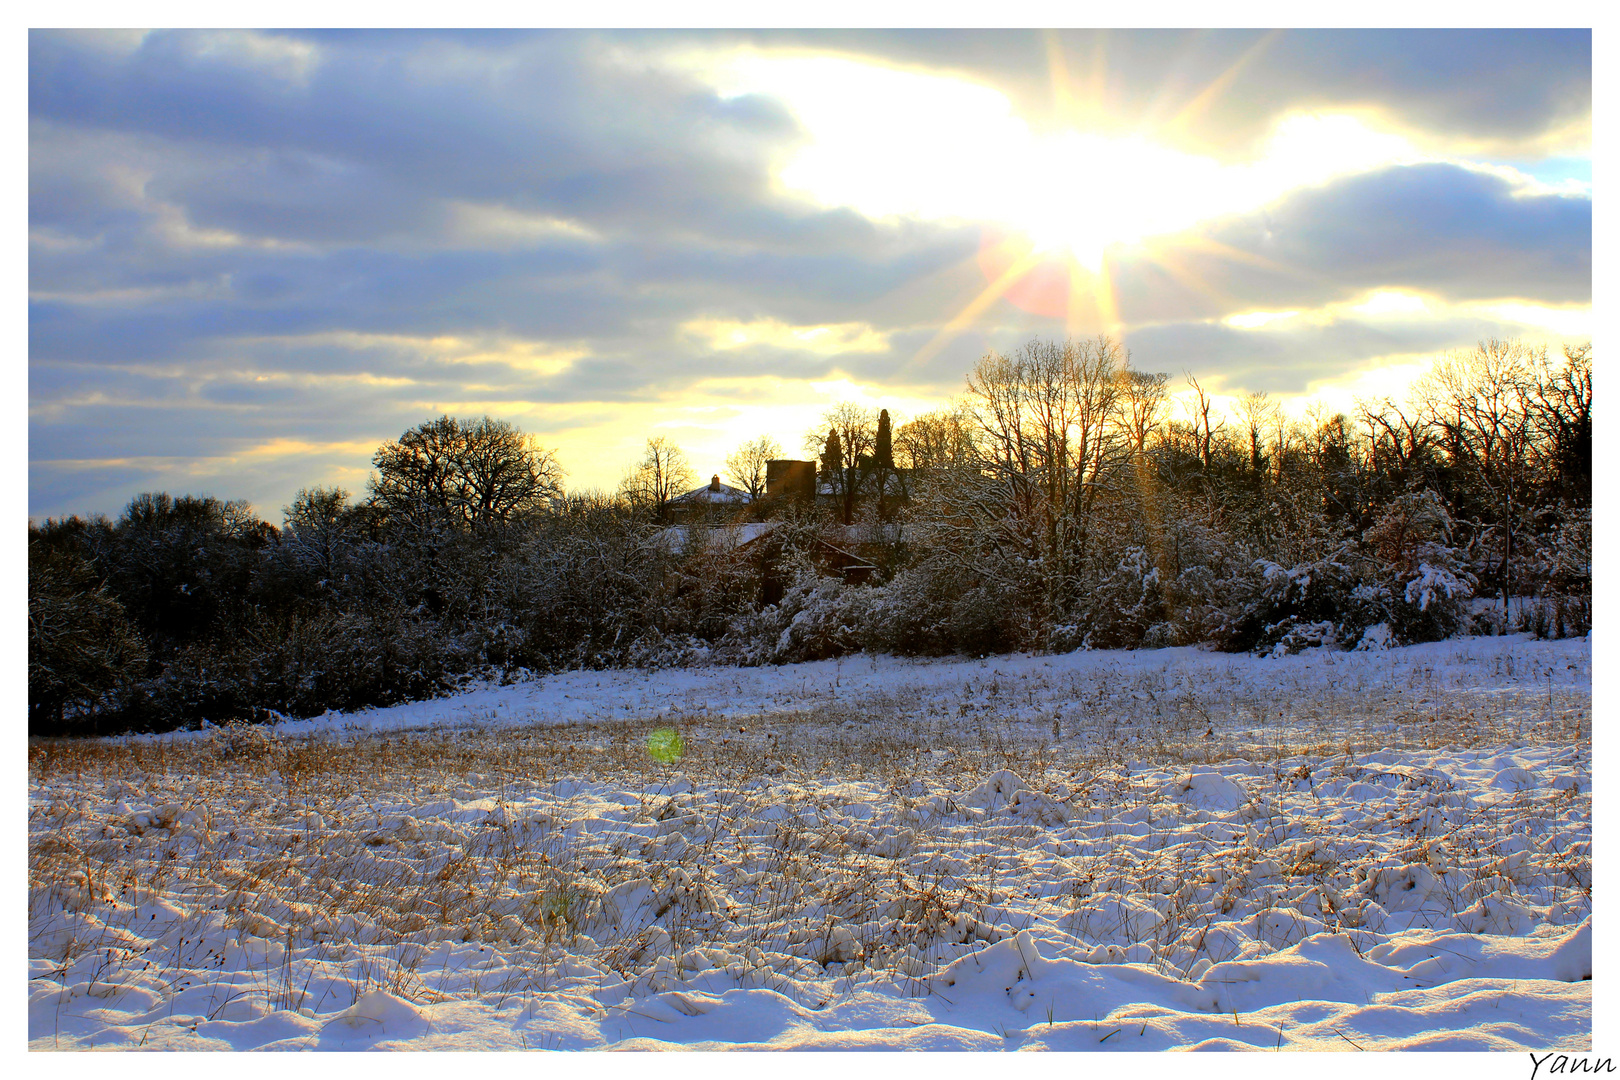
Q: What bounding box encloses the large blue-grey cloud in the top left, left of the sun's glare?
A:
[29,31,810,244]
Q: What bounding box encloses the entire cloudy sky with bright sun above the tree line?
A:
[28,31,1592,523]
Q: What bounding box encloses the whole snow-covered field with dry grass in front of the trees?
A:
[28,638,1592,1051]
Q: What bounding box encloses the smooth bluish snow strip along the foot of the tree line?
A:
[183,635,1591,748]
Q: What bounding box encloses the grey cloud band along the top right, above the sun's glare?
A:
[690,29,1592,160]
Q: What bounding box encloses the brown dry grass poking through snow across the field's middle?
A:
[28,677,1591,1042]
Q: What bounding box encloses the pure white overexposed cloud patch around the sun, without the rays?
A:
[705,50,1432,267]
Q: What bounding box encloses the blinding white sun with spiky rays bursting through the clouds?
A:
[692,46,1422,368]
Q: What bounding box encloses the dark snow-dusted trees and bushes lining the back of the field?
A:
[29,337,1592,733]
